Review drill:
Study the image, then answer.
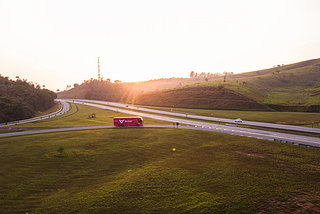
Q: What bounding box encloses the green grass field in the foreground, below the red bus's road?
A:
[0,128,320,213]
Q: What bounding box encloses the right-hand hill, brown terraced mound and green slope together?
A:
[137,59,320,112]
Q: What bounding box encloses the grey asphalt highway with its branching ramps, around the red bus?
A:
[0,99,320,148]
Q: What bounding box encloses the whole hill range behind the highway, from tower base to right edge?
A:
[58,59,320,112]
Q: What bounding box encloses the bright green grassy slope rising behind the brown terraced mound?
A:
[199,59,320,111]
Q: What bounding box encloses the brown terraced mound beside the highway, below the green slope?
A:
[135,86,272,111]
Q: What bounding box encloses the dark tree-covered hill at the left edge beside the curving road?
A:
[0,74,57,123]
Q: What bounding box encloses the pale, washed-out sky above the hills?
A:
[0,0,320,91]
